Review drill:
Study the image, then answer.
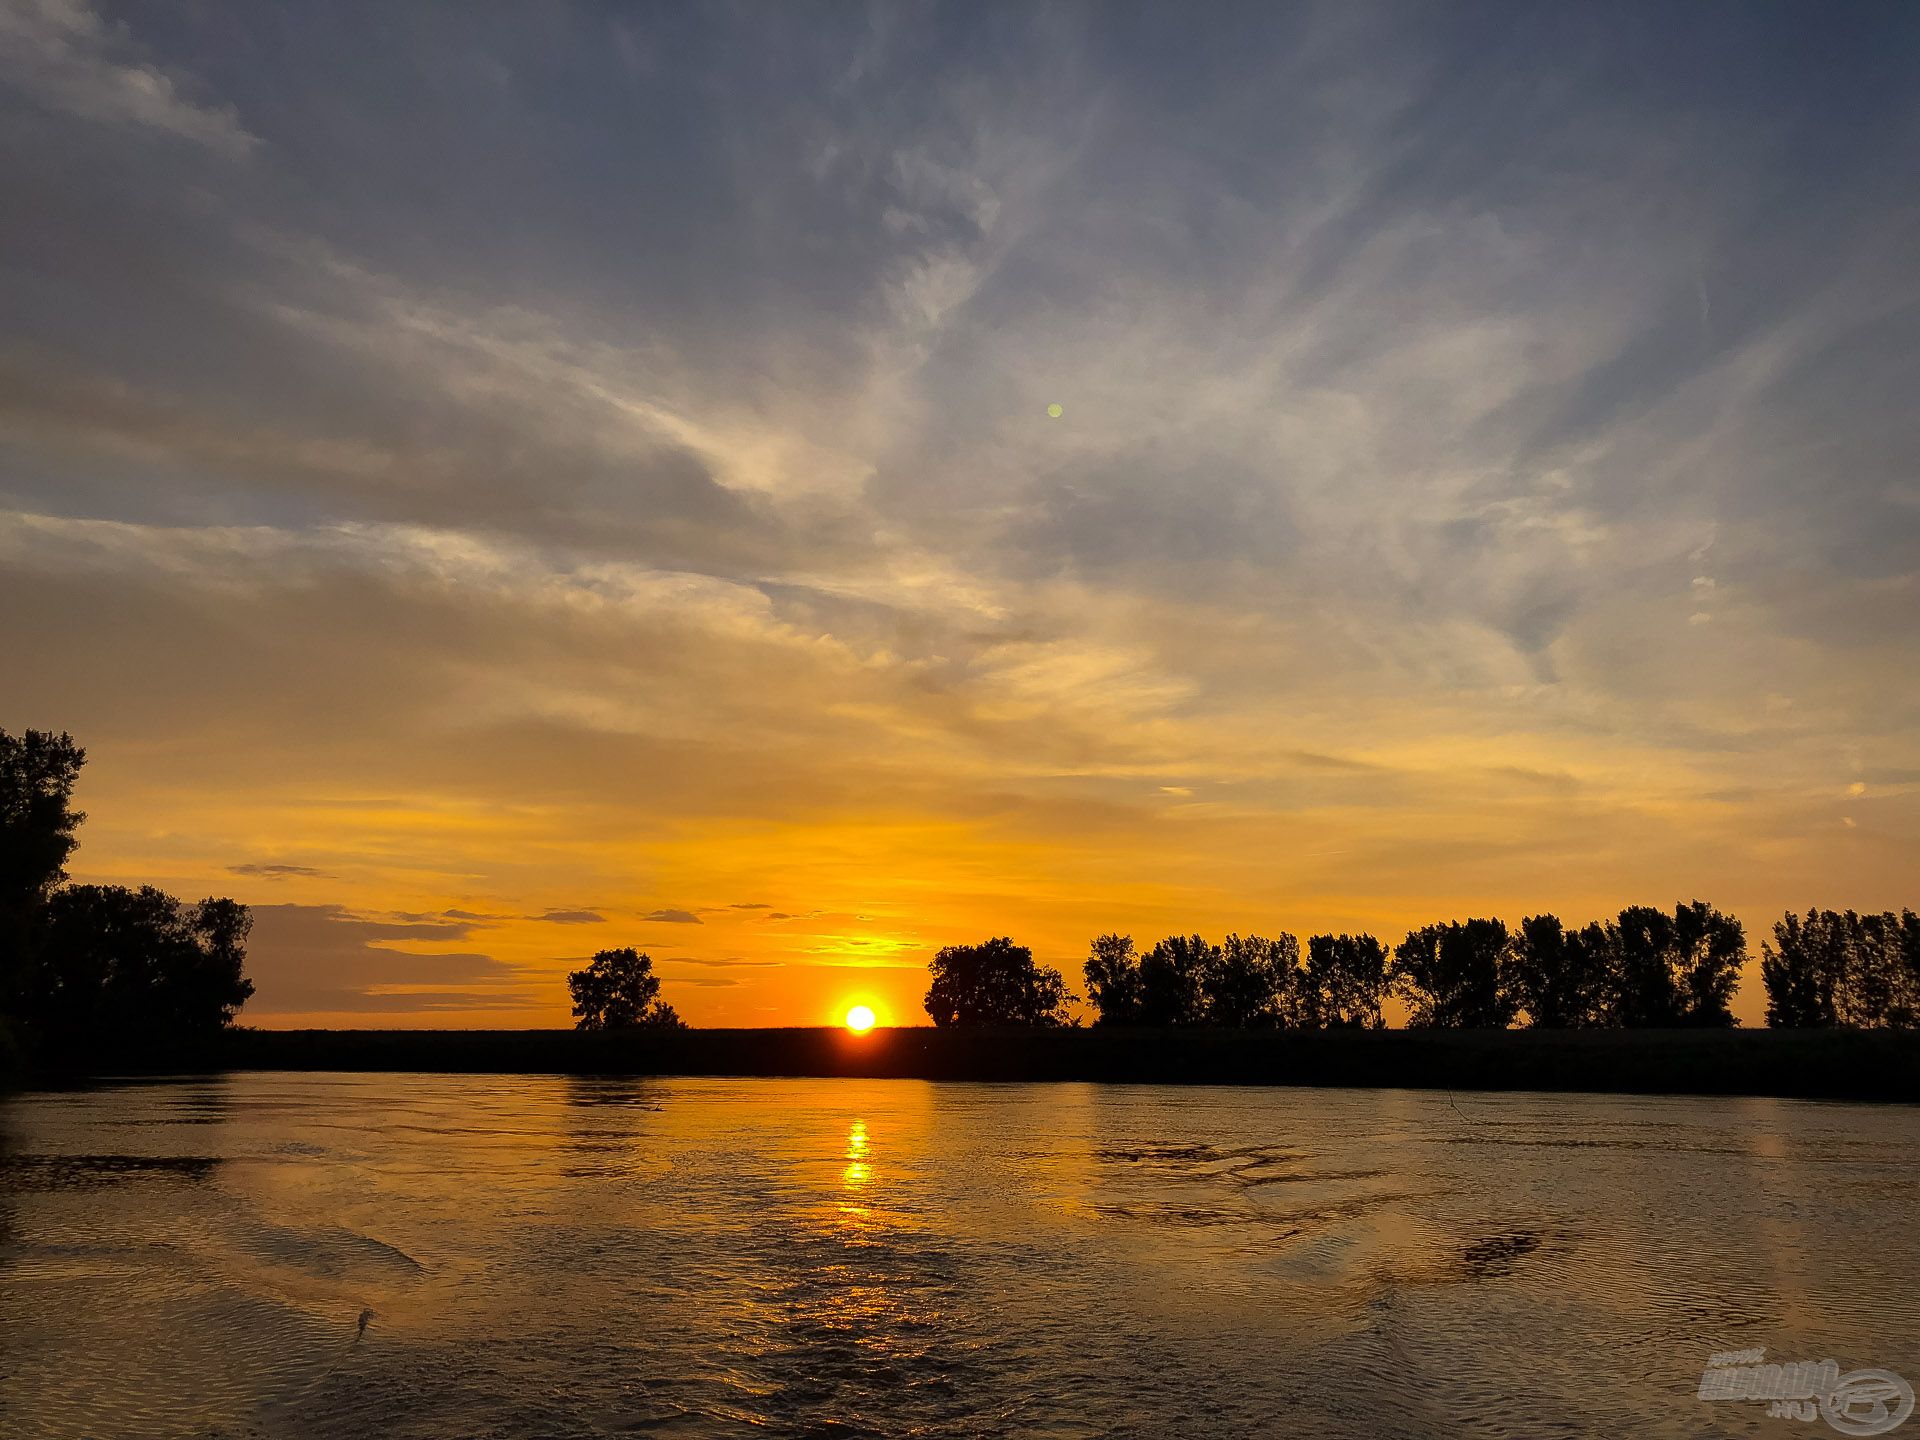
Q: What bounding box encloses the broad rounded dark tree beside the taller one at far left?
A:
[21,885,253,1044]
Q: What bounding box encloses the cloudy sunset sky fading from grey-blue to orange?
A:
[0,0,1920,1025]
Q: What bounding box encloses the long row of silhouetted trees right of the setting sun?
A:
[925,900,1920,1029]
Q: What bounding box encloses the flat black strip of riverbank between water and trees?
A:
[42,1027,1920,1102]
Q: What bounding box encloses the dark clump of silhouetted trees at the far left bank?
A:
[0,730,253,1060]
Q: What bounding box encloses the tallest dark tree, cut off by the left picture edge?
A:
[0,730,86,983]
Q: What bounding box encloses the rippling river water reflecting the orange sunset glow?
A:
[0,1075,1920,1440]
